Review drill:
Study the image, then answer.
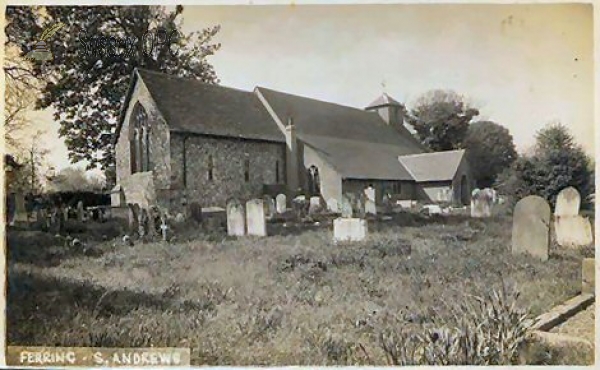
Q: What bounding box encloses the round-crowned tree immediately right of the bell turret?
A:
[406,90,479,151]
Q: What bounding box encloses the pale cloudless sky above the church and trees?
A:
[16,4,594,169]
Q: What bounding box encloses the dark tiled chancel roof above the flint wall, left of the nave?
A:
[133,69,285,142]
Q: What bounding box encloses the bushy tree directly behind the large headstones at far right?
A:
[499,123,594,207]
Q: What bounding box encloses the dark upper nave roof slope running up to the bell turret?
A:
[257,87,423,150]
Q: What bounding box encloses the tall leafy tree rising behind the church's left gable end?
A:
[6,6,220,169]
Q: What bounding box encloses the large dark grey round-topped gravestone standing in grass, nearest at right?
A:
[512,195,551,261]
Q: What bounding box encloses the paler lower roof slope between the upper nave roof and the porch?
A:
[298,135,413,181]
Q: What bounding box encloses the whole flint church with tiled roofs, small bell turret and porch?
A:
[112,69,472,209]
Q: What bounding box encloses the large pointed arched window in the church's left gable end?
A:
[129,103,150,173]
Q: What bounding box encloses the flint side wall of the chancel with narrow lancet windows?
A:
[170,133,285,207]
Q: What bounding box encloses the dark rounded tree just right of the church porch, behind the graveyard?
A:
[463,121,517,188]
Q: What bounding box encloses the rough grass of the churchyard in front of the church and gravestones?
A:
[7,213,593,365]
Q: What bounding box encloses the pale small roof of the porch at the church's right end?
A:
[398,149,465,182]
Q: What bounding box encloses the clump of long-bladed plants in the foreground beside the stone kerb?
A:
[380,286,528,366]
